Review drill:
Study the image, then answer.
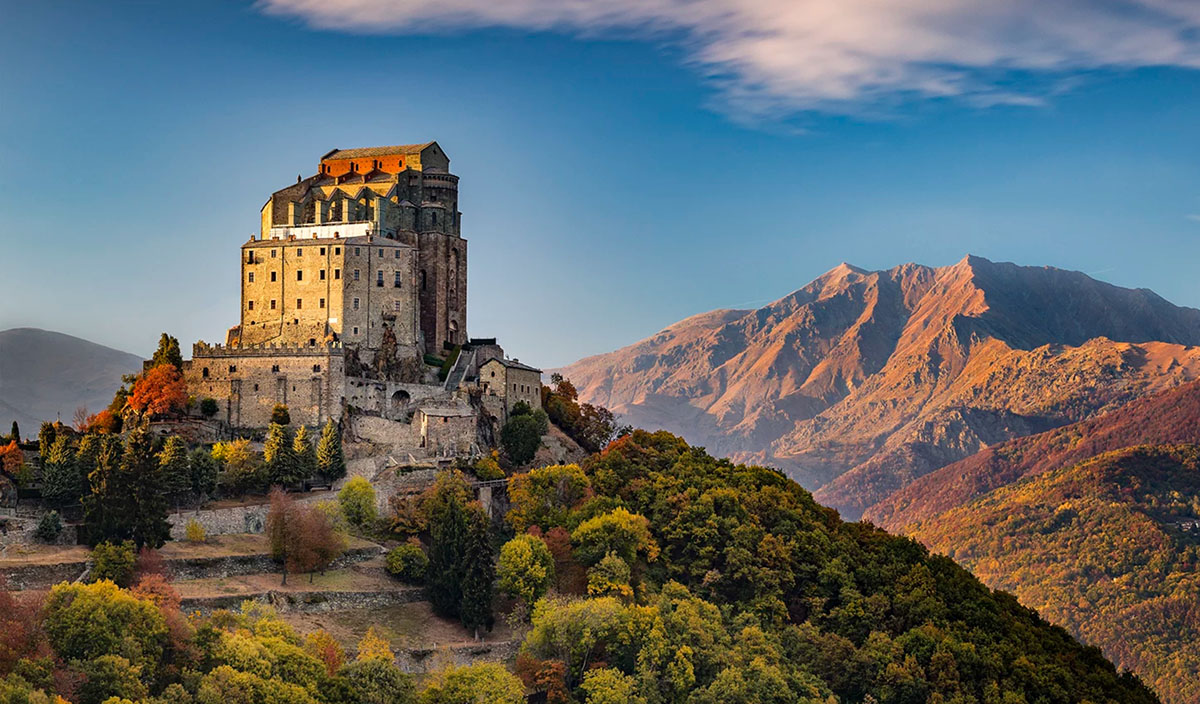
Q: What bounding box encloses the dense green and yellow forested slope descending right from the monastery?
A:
[509,431,1158,704]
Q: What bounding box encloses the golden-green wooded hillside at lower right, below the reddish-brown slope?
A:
[912,445,1200,704]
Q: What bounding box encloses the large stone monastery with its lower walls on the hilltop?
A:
[184,142,541,456]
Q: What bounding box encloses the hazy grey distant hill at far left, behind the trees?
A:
[0,327,142,437]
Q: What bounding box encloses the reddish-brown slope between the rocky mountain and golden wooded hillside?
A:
[863,383,1200,532]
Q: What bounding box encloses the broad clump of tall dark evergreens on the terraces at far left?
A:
[84,428,170,548]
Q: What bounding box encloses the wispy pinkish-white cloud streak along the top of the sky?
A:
[259,0,1200,118]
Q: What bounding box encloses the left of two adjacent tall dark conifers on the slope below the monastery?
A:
[425,487,469,618]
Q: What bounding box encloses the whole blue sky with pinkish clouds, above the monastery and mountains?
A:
[0,0,1200,367]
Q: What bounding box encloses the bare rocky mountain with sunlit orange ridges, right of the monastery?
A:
[563,257,1200,518]
